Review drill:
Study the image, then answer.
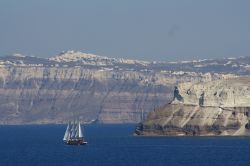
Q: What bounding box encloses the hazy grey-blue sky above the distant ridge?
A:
[0,0,250,61]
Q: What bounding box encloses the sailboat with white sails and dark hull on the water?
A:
[63,121,87,145]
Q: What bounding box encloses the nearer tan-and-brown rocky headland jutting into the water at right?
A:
[136,77,250,136]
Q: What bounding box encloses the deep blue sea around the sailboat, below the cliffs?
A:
[0,125,250,166]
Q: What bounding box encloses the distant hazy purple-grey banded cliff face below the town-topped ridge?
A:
[0,67,172,124]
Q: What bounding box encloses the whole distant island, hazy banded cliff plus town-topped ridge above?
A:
[0,51,244,124]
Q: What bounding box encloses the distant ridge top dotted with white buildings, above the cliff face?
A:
[0,50,250,75]
